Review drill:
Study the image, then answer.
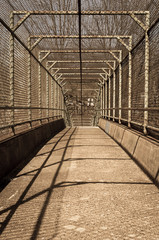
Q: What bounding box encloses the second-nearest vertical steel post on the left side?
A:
[28,38,32,124]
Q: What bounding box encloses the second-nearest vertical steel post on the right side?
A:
[128,37,132,127]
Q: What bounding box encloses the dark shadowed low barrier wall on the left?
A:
[0,119,65,180]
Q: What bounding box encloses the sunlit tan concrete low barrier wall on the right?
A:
[98,118,159,185]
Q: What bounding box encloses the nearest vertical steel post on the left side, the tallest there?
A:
[9,13,15,124]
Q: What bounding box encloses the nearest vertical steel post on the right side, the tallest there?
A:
[144,13,150,134]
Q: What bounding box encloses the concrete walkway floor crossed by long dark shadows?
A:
[0,127,159,240]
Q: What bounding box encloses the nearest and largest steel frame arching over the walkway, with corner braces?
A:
[10,11,150,134]
